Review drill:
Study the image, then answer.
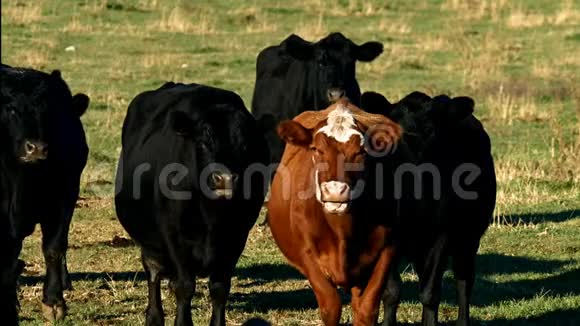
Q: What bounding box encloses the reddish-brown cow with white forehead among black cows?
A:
[268,100,402,325]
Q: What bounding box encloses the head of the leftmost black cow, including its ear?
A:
[0,66,89,163]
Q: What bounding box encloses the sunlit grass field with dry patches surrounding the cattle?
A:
[2,0,580,325]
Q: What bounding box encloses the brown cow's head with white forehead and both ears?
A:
[278,99,402,214]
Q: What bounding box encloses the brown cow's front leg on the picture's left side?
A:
[301,258,342,326]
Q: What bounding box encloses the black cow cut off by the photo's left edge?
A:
[0,65,89,323]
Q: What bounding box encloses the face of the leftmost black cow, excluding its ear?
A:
[0,85,48,163]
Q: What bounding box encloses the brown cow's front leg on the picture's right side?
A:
[352,246,395,326]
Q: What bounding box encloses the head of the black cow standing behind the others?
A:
[284,33,383,109]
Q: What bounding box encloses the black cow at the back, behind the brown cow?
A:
[252,33,383,163]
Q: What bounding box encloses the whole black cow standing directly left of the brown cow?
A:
[115,83,269,325]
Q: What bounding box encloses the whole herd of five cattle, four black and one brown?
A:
[0,33,496,325]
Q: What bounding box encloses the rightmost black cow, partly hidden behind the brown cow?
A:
[361,92,496,326]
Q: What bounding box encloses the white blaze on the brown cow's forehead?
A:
[316,105,364,146]
